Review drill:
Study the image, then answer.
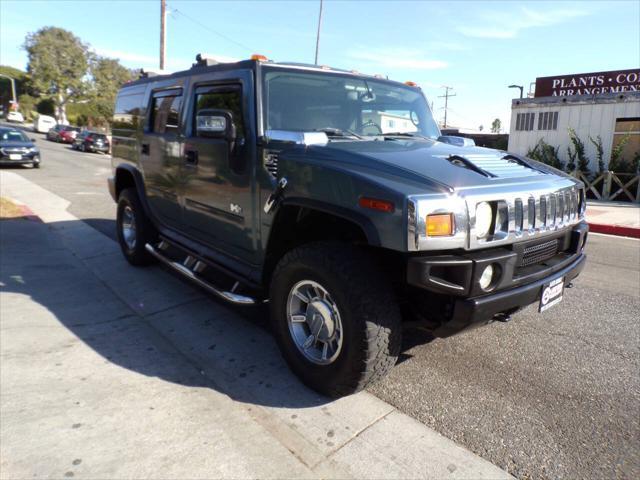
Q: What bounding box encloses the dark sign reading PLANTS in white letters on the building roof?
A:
[535,69,640,98]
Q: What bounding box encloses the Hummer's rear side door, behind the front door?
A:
[140,88,186,228]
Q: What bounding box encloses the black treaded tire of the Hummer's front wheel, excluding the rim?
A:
[270,243,402,397]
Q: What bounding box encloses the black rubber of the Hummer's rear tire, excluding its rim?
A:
[116,188,158,266]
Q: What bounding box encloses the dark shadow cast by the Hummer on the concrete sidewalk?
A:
[0,220,340,409]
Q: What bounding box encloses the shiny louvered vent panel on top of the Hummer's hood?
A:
[446,154,545,178]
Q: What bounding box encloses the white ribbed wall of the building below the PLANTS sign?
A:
[508,95,640,171]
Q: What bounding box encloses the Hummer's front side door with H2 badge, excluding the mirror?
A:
[184,83,254,262]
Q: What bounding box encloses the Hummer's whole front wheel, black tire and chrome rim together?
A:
[270,243,401,397]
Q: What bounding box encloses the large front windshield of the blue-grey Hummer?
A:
[263,69,440,139]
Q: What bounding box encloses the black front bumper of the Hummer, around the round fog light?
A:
[407,222,589,337]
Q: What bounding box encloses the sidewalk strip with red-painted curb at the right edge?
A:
[587,200,640,238]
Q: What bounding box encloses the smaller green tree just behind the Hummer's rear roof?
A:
[89,56,135,122]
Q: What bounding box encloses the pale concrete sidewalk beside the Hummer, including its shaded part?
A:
[0,172,510,479]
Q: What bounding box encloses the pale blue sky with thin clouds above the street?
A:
[0,0,640,131]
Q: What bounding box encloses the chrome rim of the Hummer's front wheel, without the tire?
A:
[287,280,343,365]
